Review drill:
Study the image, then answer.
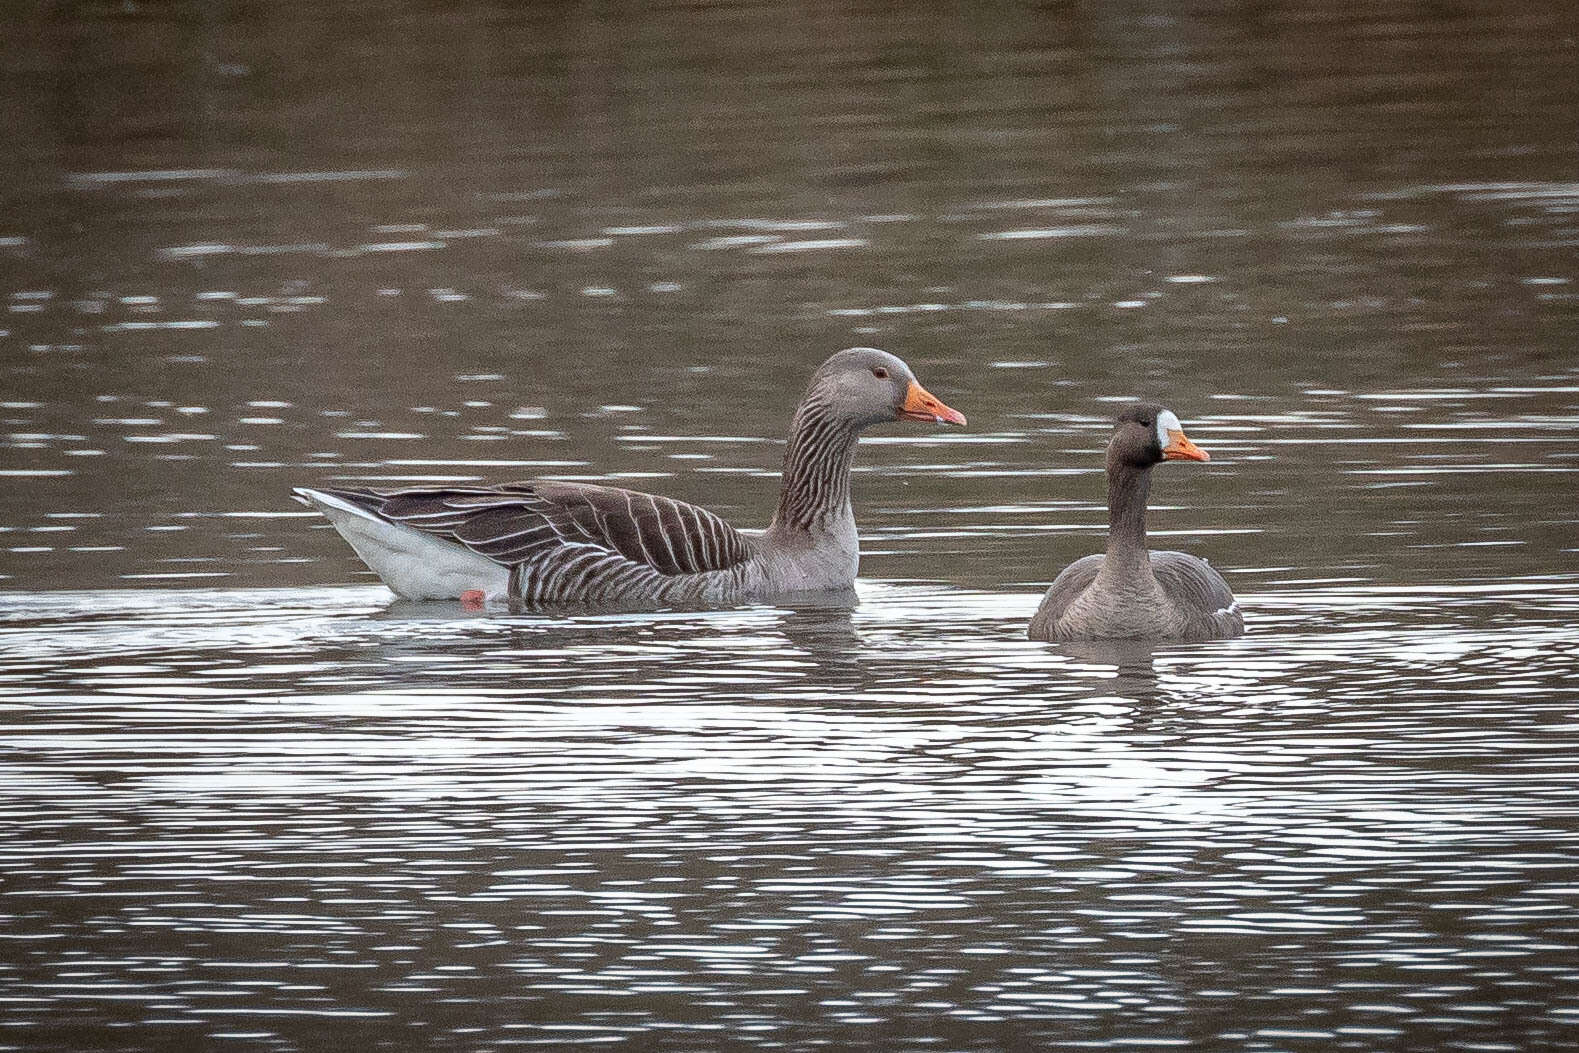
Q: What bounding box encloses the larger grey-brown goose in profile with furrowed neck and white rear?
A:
[295,347,965,608]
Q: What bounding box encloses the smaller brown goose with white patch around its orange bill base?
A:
[1030,404,1244,641]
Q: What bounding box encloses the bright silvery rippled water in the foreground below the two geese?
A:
[0,579,1579,1048]
